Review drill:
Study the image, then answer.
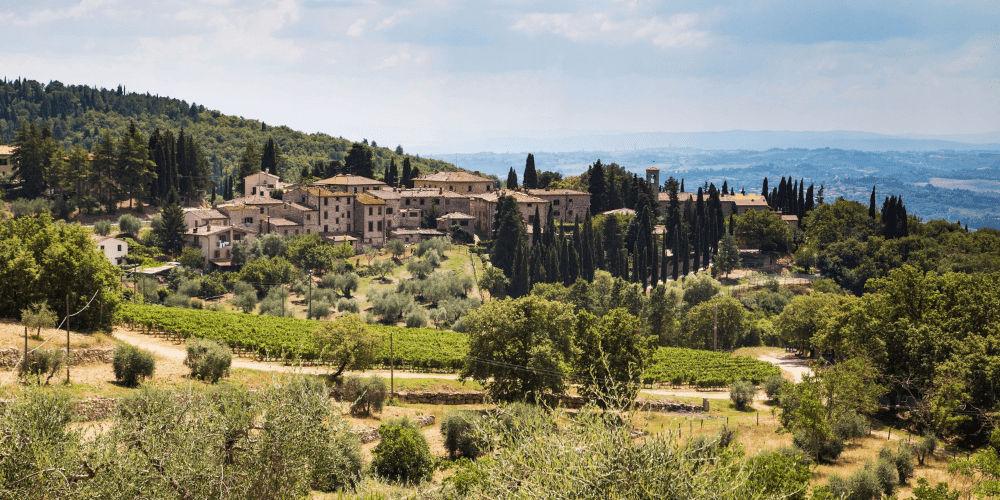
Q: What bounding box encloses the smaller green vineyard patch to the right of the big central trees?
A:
[643,347,781,387]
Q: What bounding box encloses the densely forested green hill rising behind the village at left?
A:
[0,79,456,182]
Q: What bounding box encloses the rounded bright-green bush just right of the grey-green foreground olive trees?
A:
[372,417,434,483]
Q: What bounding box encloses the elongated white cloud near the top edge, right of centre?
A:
[511,13,709,49]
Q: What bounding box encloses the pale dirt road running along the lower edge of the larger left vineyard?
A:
[114,327,458,380]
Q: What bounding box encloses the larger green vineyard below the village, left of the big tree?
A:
[118,304,468,370]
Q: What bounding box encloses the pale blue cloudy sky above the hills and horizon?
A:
[0,0,1000,152]
